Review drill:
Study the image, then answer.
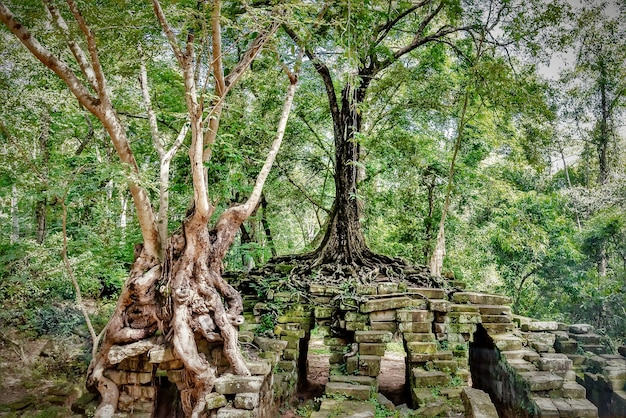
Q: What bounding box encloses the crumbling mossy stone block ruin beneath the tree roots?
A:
[78,282,626,418]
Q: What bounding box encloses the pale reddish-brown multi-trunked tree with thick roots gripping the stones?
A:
[0,0,301,417]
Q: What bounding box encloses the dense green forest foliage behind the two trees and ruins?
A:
[0,1,626,382]
